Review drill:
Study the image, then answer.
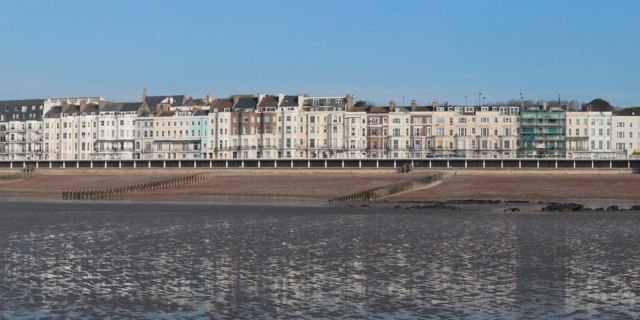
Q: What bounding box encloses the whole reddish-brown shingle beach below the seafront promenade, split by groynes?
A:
[0,169,640,207]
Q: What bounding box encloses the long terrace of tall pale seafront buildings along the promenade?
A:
[0,93,640,161]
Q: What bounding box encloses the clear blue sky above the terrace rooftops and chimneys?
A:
[0,0,640,106]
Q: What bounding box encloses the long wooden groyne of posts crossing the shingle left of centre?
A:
[62,172,222,200]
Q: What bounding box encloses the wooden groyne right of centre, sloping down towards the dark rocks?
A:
[329,172,445,202]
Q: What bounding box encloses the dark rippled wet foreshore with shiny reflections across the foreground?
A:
[0,203,640,319]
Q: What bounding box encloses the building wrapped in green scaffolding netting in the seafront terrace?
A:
[518,106,567,158]
